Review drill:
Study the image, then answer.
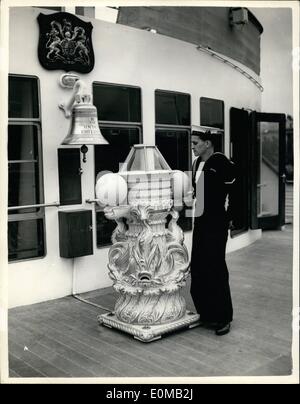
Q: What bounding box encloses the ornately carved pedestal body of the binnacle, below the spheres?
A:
[105,200,189,325]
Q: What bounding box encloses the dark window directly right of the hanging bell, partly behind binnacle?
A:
[93,83,142,247]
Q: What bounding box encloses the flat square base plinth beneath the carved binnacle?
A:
[98,311,200,342]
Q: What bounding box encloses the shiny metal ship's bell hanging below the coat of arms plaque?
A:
[61,94,108,145]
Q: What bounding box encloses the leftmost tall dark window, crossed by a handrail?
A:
[8,75,45,261]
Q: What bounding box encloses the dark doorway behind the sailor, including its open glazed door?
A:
[230,108,286,232]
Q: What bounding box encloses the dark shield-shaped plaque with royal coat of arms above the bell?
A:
[37,12,95,73]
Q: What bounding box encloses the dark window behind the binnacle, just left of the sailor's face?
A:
[155,90,192,230]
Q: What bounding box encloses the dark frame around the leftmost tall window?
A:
[7,74,47,263]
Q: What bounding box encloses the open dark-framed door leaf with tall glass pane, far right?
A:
[250,112,285,229]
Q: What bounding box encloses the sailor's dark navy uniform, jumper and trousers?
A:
[191,153,236,324]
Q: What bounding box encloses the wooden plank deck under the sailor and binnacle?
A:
[9,225,292,378]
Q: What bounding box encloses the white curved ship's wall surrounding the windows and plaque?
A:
[8,7,261,307]
